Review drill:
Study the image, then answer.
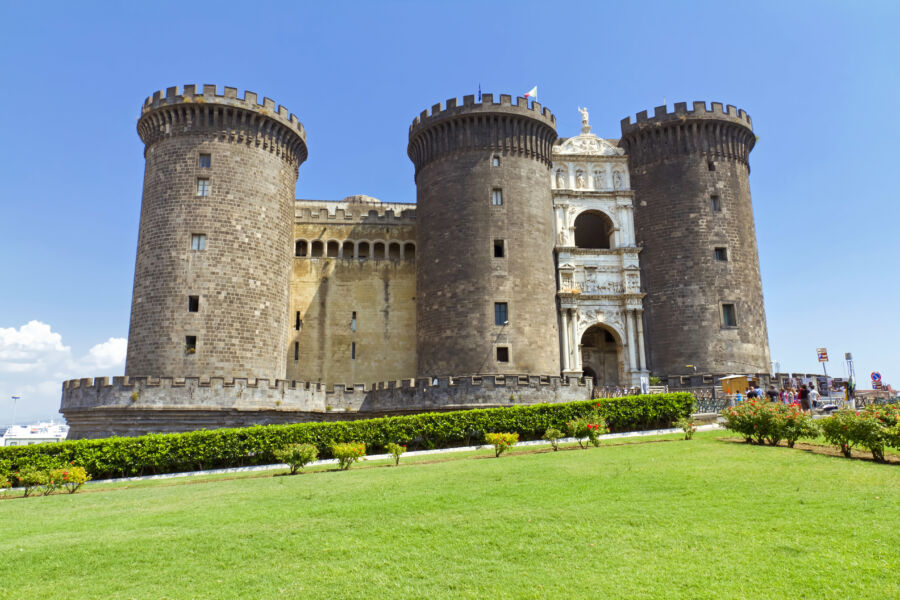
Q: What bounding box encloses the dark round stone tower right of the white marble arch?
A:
[620,102,769,376]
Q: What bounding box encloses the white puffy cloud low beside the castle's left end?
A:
[0,321,127,424]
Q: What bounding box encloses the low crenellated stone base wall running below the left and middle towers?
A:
[60,375,591,439]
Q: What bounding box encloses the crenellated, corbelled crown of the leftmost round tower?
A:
[137,84,308,166]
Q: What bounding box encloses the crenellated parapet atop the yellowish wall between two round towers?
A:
[294,195,416,225]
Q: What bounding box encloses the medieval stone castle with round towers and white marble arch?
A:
[61,85,769,438]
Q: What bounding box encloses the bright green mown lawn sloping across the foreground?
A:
[0,432,900,598]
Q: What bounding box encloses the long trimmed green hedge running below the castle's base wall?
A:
[0,393,694,479]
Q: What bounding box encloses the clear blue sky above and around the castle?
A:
[0,0,900,423]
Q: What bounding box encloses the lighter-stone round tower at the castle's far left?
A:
[125,85,307,379]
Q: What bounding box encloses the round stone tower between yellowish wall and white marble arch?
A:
[408,94,560,377]
